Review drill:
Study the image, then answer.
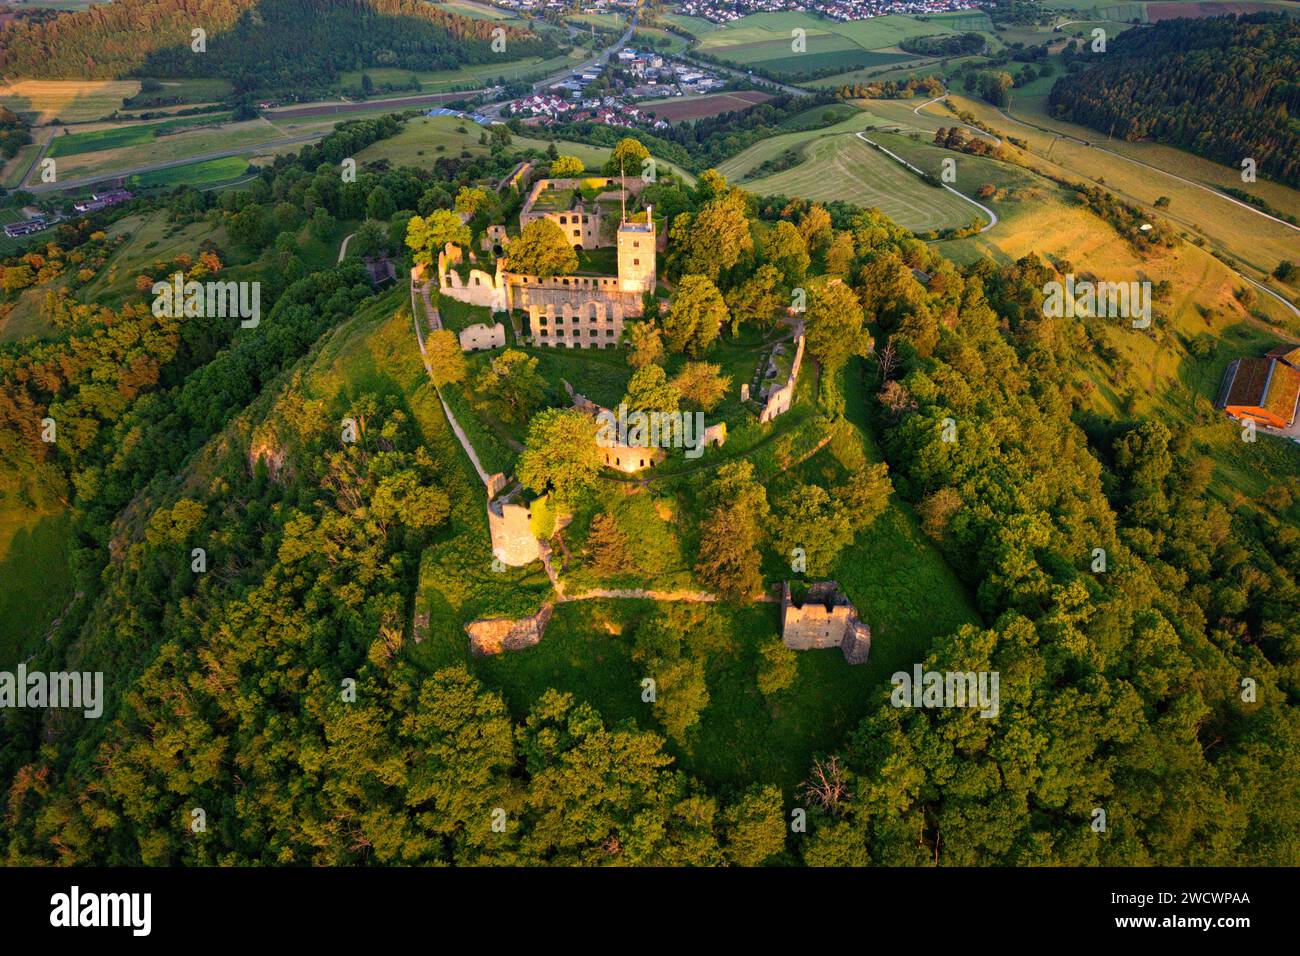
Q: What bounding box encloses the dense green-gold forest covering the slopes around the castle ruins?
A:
[0,106,1300,865]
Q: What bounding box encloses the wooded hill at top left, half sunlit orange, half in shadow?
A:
[0,0,550,90]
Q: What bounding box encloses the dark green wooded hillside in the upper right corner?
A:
[1049,13,1300,186]
